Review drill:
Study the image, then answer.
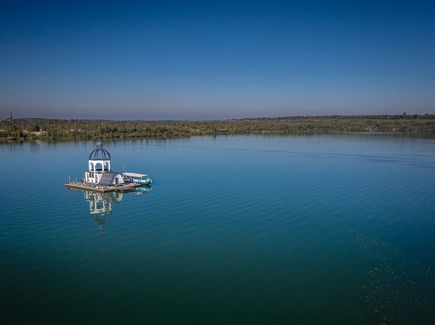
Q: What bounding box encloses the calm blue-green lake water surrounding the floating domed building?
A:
[0,135,435,324]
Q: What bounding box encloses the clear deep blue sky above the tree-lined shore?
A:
[0,0,435,119]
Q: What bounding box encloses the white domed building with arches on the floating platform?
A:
[84,144,124,186]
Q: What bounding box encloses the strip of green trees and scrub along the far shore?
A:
[0,113,435,142]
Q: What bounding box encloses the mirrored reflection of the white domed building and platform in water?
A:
[83,187,151,230]
